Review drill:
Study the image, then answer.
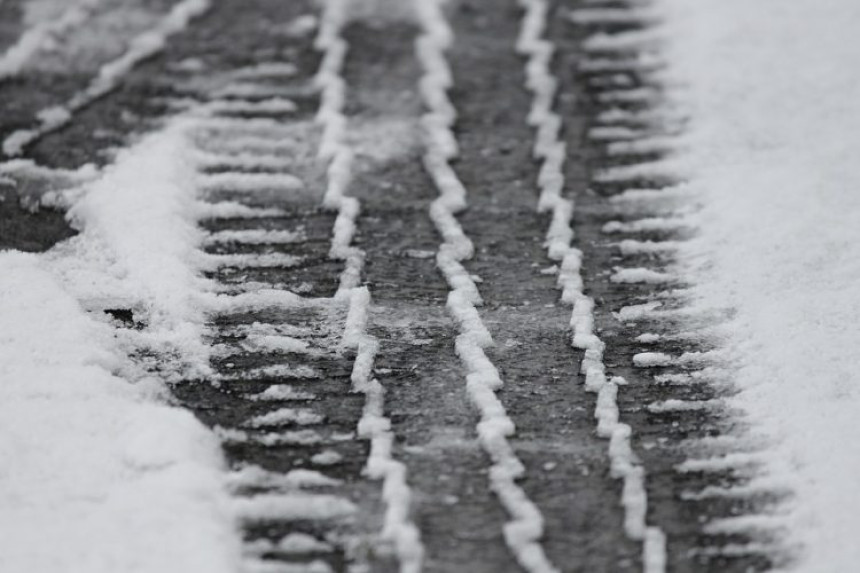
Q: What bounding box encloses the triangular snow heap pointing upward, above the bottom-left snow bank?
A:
[53,121,211,377]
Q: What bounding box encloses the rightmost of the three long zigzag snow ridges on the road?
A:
[516,0,666,573]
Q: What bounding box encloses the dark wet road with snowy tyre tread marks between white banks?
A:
[0,0,781,573]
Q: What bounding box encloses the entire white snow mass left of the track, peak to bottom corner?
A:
[0,120,240,573]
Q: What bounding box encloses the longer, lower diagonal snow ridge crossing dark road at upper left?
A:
[3,0,211,156]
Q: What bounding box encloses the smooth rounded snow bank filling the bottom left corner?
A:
[0,252,239,573]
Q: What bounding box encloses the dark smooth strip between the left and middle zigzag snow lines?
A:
[344,11,516,573]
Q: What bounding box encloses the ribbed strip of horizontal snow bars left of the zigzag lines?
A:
[153,17,392,571]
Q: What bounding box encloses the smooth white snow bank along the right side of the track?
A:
[657,0,860,572]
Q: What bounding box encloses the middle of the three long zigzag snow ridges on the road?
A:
[415,0,558,573]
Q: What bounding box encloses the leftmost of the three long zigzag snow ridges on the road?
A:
[315,0,424,573]
